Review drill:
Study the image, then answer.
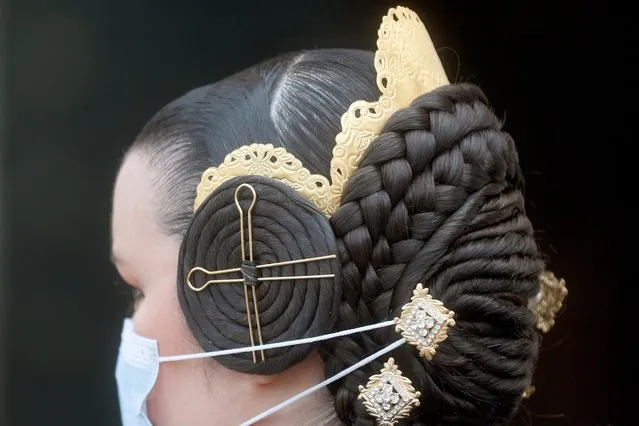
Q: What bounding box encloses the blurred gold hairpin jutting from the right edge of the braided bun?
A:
[531,271,568,333]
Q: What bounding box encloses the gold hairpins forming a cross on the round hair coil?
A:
[186,183,337,363]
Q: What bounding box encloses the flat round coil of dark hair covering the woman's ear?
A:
[177,176,341,374]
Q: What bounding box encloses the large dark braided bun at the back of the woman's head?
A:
[326,84,543,425]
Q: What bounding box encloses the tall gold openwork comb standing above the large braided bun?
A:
[331,6,449,211]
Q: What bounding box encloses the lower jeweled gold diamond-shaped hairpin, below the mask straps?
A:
[357,358,421,426]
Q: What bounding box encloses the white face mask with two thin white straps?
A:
[115,318,398,426]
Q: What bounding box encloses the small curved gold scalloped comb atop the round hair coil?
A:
[194,143,331,215]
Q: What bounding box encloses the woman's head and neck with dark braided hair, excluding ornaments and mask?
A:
[113,28,543,426]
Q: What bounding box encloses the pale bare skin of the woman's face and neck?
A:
[111,152,331,426]
